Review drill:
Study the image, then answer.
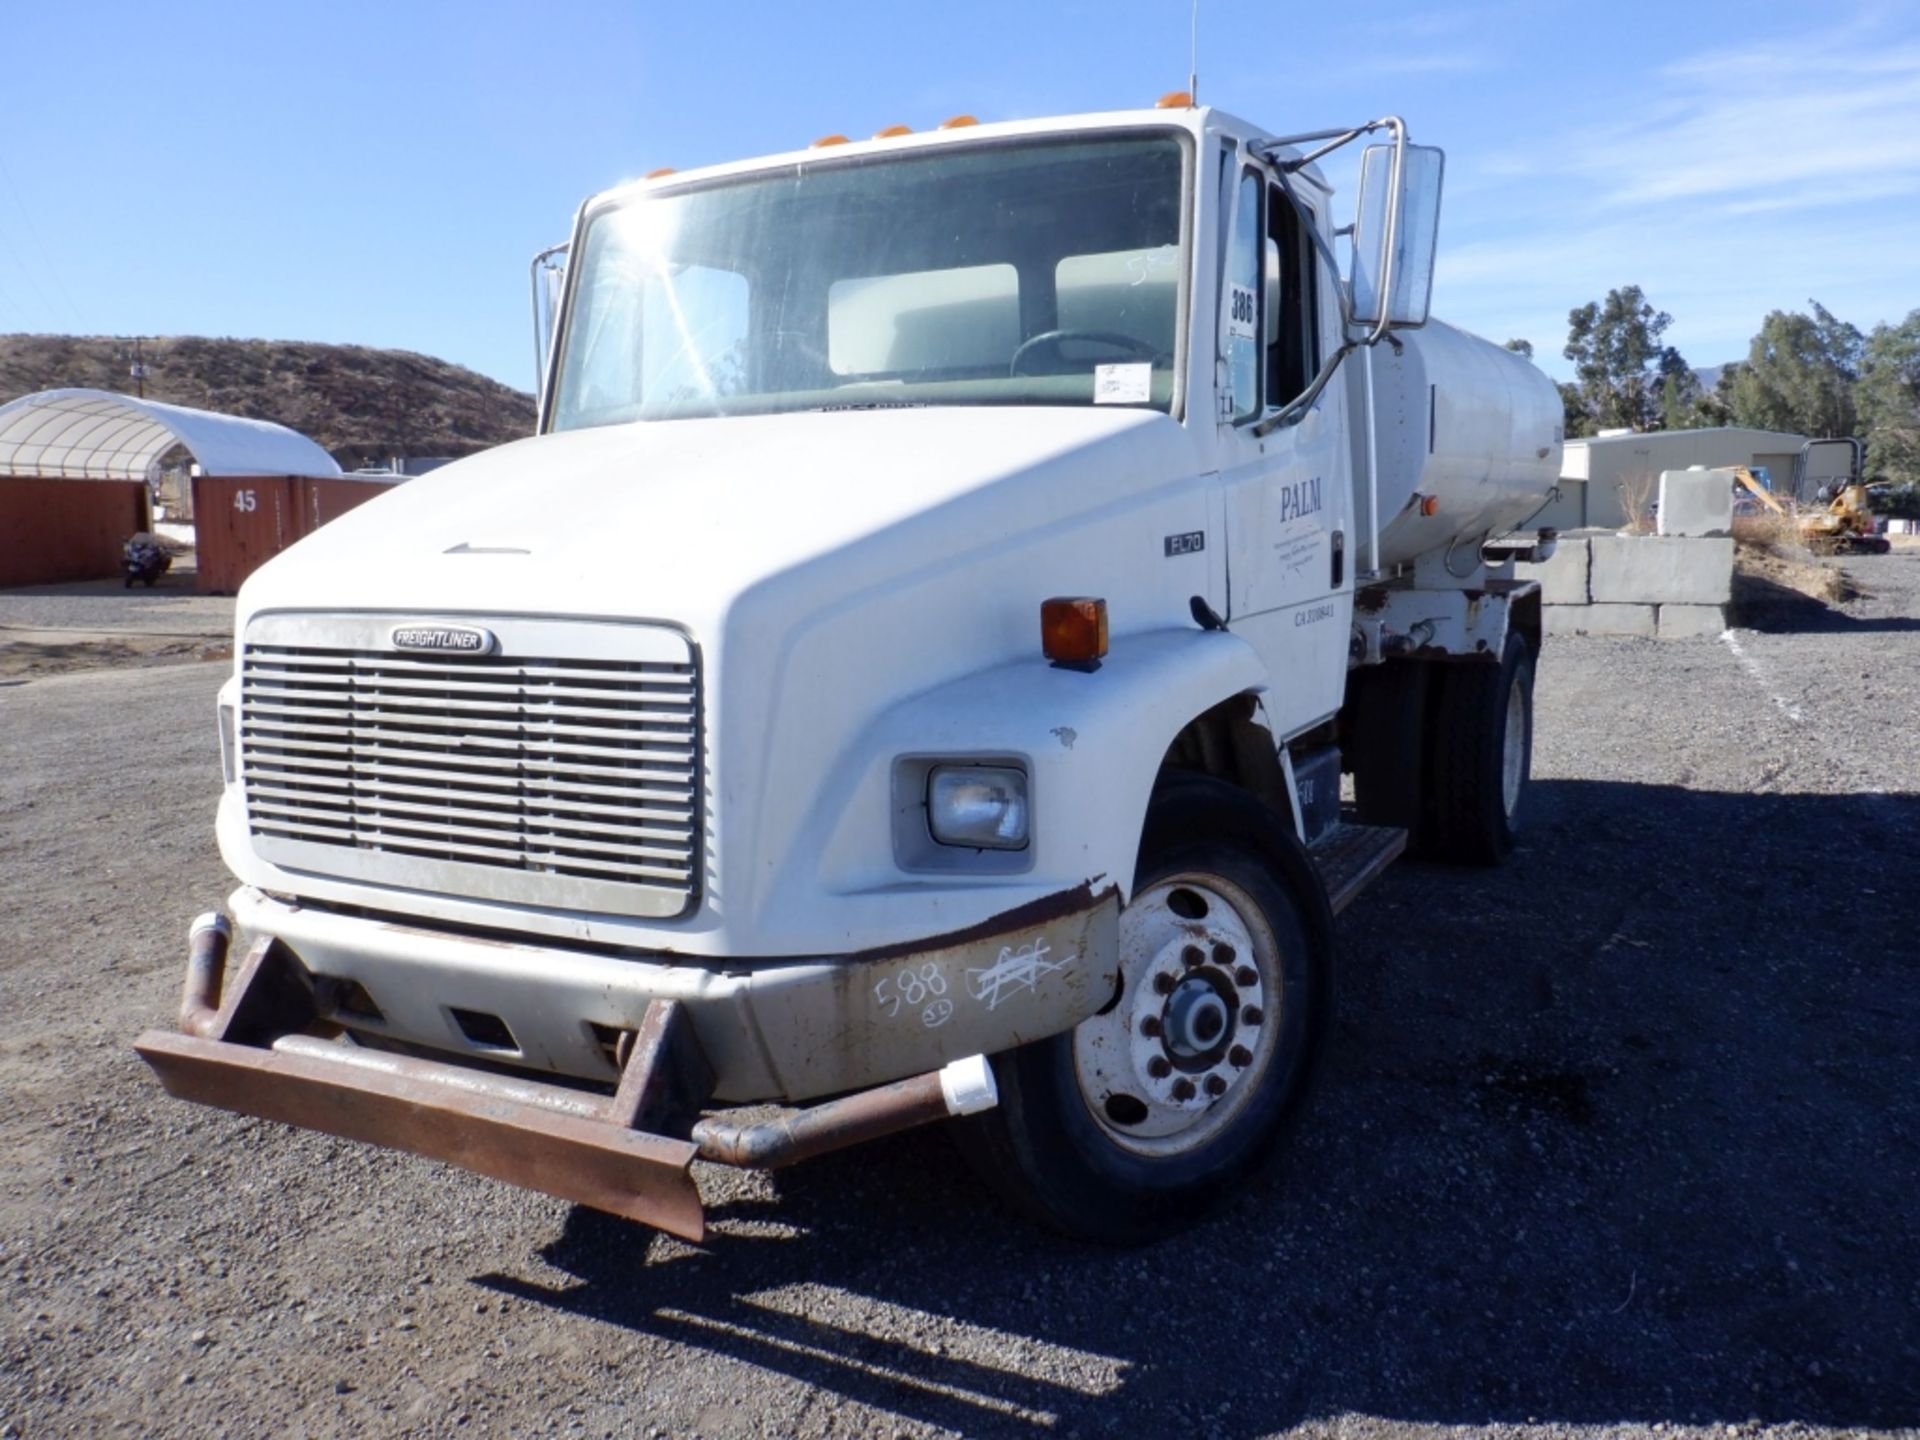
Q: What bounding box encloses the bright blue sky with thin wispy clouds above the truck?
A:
[0,0,1920,388]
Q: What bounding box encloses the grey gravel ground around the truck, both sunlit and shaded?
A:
[0,551,1920,1440]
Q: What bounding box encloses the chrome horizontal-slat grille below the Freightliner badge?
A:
[240,622,701,914]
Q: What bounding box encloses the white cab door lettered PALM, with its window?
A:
[1215,152,1354,735]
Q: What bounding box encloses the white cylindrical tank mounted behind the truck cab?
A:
[1348,321,1565,570]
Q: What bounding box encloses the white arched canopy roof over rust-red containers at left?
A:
[0,390,340,480]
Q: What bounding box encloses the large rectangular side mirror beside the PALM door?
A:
[1350,144,1446,340]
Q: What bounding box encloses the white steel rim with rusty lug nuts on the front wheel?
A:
[1073,876,1281,1156]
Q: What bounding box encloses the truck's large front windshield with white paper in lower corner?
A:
[553,132,1187,430]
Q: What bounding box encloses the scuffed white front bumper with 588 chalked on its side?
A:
[232,887,1119,1102]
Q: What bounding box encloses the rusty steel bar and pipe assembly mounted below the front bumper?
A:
[134,914,998,1240]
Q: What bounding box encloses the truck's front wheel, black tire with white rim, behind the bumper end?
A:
[962,781,1331,1244]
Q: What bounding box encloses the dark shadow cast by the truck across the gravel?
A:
[478,781,1920,1436]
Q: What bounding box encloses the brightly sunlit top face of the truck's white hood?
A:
[240,409,1175,634]
